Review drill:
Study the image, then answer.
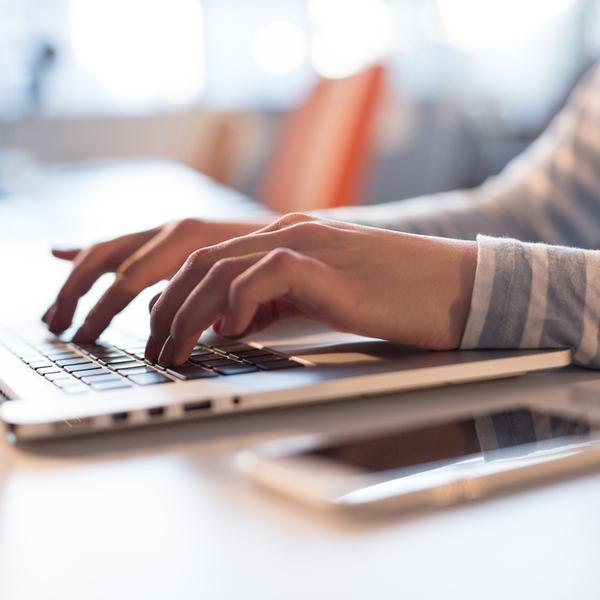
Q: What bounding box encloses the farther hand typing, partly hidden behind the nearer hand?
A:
[42,217,275,343]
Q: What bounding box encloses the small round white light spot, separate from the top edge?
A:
[252,21,307,75]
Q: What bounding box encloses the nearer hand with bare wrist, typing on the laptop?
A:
[146,214,477,365]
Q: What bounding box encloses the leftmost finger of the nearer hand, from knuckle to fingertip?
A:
[150,215,338,347]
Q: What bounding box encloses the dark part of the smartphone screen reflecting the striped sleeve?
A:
[306,408,600,473]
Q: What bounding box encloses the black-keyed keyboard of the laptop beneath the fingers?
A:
[0,328,304,394]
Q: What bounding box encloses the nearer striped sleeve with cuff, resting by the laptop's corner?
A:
[461,236,600,369]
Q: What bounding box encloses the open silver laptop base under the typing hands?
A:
[0,314,571,441]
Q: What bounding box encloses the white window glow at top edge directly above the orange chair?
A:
[308,0,394,79]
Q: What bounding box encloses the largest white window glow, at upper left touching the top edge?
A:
[70,0,205,105]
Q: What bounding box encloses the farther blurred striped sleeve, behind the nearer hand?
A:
[316,61,600,248]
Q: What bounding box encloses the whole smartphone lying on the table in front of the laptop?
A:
[237,407,600,511]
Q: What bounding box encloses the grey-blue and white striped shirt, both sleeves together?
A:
[315,65,600,369]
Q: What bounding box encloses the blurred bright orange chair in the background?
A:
[256,65,384,213]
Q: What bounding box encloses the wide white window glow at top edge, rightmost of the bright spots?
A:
[437,0,575,50]
